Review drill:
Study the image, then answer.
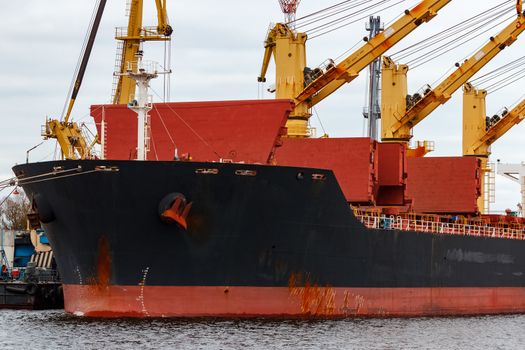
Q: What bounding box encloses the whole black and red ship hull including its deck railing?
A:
[13,160,525,317]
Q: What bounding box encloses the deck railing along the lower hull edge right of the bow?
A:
[355,212,525,240]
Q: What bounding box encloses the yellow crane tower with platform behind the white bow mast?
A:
[112,0,173,104]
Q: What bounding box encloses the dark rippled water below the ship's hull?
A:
[0,310,525,350]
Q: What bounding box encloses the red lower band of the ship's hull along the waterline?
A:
[64,285,525,318]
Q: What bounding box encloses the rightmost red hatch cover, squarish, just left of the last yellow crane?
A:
[407,157,481,214]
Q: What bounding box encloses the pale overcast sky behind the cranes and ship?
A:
[0,0,525,210]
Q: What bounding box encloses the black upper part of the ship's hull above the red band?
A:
[14,160,525,318]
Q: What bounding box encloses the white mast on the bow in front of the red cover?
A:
[117,51,170,160]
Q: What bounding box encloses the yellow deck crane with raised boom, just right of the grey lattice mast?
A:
[381,0,525,143]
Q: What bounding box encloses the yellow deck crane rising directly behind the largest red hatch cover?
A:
[259,0,451,137]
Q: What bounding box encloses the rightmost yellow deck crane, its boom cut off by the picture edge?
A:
[463,84,525,211]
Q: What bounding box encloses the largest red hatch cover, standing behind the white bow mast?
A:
[91,100,293,163]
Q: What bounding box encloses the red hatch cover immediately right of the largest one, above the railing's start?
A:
[275,137,376,203]
